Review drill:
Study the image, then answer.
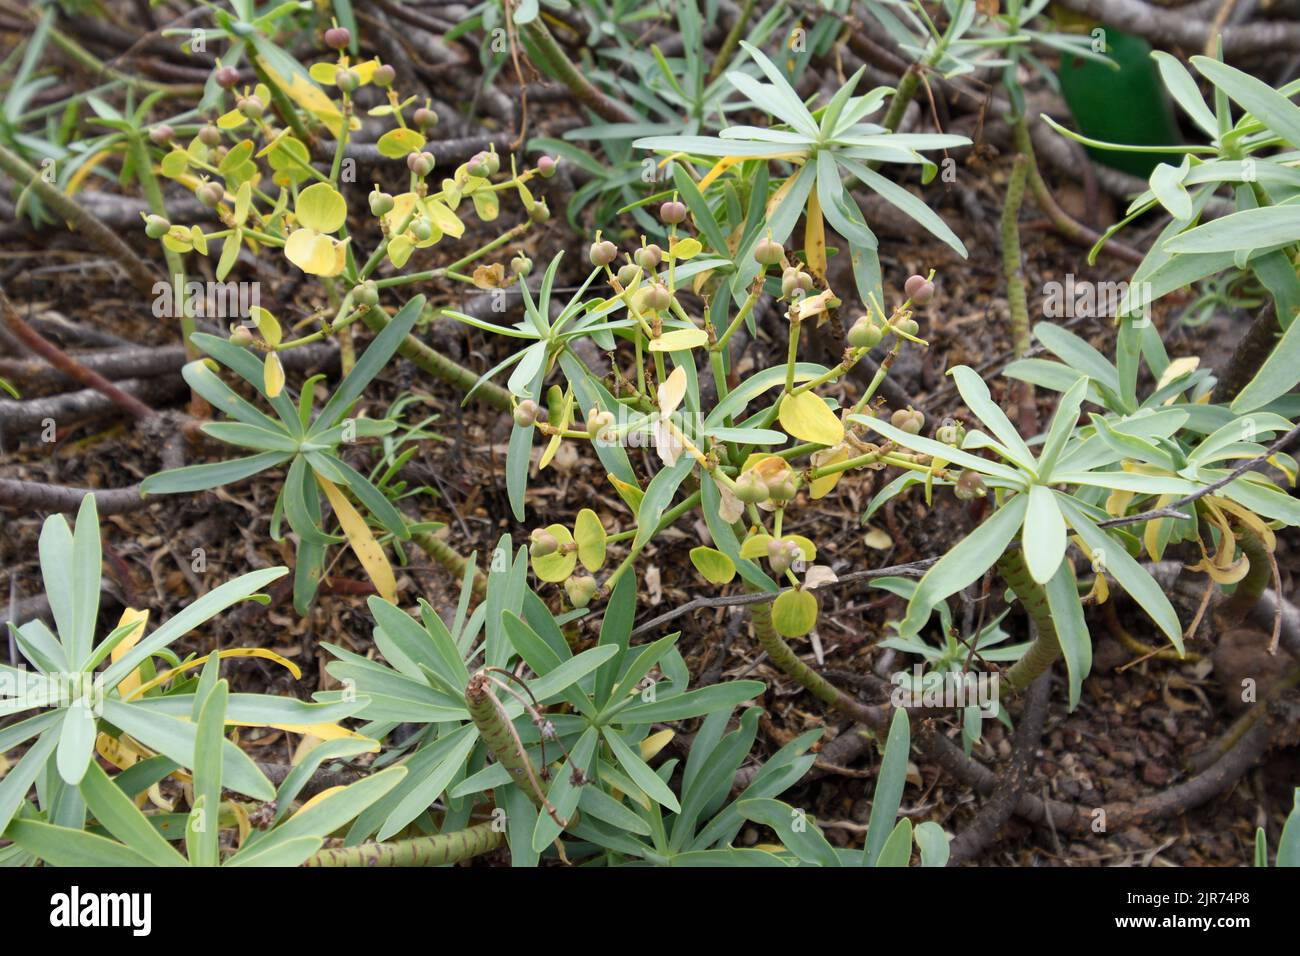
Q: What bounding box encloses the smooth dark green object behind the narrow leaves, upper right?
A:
[1057,27,1183,179]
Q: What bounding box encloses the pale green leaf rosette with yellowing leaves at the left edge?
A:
[0,494,360,829]
